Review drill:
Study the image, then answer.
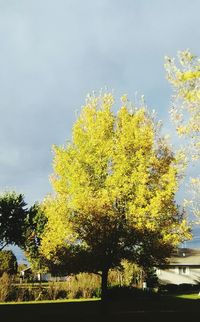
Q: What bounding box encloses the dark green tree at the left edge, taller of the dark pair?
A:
[0,192,27,250]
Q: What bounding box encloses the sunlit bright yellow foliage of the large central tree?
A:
[41,93,191,256]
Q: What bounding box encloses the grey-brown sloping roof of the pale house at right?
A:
[168,248,200,266]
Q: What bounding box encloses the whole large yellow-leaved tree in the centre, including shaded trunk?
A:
[41,93,189,298]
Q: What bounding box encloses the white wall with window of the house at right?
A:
[156,267,200,285]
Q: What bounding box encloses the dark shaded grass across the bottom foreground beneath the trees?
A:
[0,296,200,322]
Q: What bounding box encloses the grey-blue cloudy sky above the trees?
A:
[0,0,200,203]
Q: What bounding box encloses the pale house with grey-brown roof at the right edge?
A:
[156,248,200,285]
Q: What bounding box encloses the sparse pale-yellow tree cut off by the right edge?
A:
[165,50,200,216]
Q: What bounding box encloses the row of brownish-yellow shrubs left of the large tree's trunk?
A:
[0,273,100,302]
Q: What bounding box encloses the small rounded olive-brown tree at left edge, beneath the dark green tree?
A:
[0,250,17,276]
